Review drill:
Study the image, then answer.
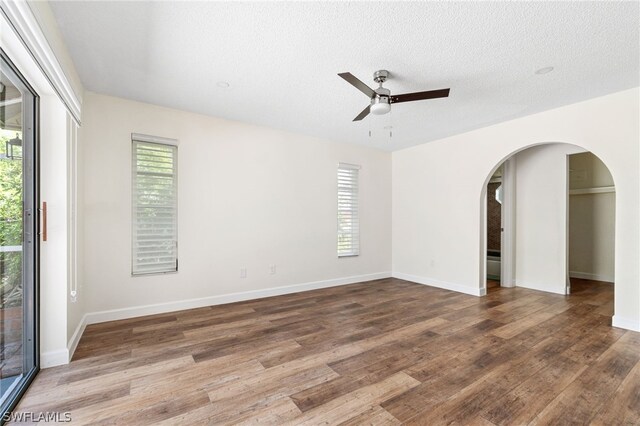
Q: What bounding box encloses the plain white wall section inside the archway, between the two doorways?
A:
[514,144,583,294]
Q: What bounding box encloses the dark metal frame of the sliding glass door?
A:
[0,48,40,424]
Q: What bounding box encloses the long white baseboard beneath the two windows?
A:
[82,272,391,326]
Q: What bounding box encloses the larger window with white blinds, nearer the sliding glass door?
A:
[131,134,178,275]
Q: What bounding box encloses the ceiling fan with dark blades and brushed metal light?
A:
[338,70,449,121]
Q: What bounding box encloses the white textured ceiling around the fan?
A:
[51,1,640,150]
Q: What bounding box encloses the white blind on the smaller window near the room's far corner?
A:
[338,163,360,257]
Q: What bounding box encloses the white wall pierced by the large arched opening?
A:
[392,88,640,330]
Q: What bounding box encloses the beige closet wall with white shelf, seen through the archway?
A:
[569,152,616,282]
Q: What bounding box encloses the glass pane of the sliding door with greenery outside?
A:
[0,50,38,414]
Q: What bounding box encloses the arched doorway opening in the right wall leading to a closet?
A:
[480,143,615,316]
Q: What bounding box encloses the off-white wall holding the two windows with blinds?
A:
[80,93,391,321]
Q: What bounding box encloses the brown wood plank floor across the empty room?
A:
[10,279,640,425]
